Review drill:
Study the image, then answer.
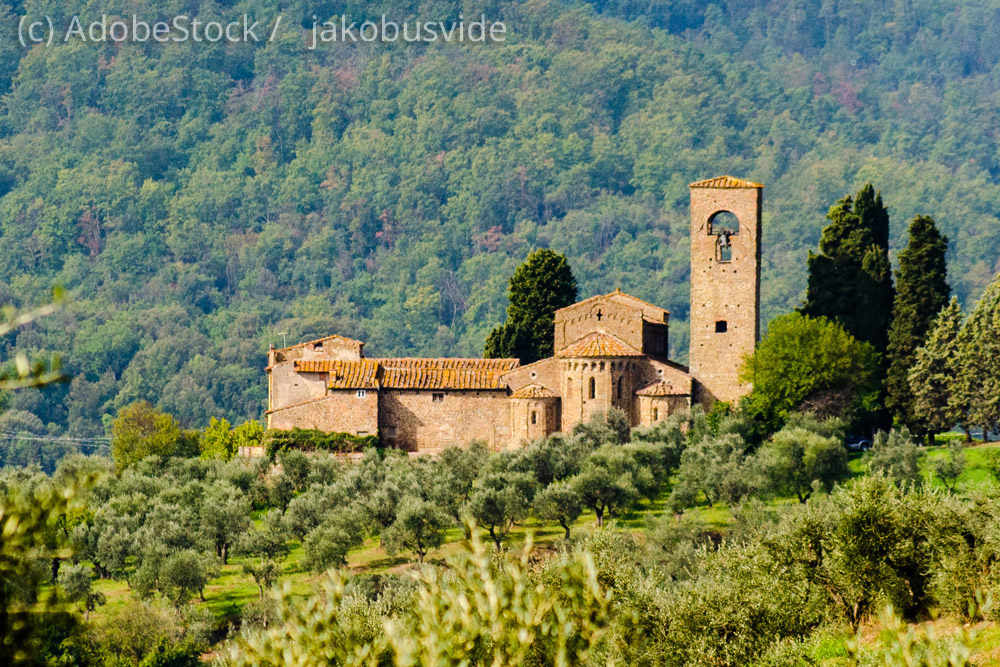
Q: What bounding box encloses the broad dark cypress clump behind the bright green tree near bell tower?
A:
[800,183,893,353]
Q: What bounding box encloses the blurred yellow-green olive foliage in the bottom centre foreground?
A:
[227,527,611,667]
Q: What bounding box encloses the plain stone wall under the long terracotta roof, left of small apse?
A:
[379,390,511,452]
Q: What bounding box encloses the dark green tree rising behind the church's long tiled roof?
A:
[484,248,576,364]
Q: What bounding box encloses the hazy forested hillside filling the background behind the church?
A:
[0,0,1000,436]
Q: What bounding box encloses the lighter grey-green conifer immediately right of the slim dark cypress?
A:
[907,297,968,443]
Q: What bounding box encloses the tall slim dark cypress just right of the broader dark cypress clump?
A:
[886,215,954,435]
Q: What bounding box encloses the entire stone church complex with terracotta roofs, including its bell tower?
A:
[267,176,763,452]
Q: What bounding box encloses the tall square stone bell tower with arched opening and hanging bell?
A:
[689,176,764,408]
